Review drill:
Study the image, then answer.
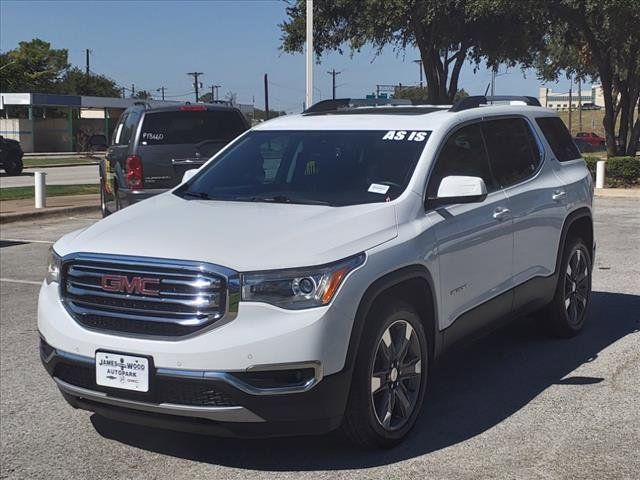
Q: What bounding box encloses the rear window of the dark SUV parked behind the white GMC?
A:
[140,110,246,145]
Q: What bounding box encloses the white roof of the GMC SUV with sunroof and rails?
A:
[254,98,557,131]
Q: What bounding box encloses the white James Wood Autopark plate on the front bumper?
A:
[96,352,149,392]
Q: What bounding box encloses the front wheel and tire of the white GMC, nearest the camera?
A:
[342,300,429,448]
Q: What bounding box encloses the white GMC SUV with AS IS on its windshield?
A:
[38,97,595,447]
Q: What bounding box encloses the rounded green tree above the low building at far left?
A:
[0,38,69,93]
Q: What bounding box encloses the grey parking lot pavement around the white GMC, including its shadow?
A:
[0,199,640,480]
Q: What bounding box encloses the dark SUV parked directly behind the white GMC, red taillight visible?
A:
[100,102,249,216]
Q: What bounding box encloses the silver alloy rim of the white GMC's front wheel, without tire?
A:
[371,320,423,430]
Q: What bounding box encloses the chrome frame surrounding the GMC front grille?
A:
[58,252,240,341]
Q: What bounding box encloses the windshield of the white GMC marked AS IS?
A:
[176,130,430,206]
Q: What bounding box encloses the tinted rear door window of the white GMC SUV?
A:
[482,118,541,188]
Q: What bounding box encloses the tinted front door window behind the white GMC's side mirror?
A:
[427,124,498,198]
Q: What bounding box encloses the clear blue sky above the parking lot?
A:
[0,0,569,113]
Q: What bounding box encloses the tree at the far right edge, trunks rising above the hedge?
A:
[529,0,640,155]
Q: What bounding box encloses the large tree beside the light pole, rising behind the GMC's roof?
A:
[280,0,537,104]
